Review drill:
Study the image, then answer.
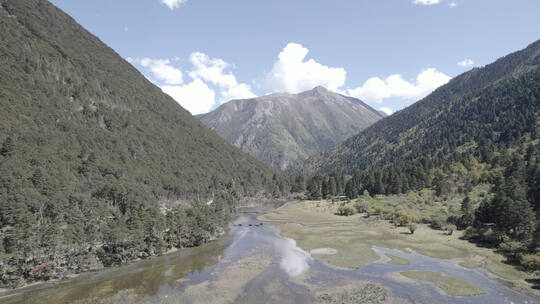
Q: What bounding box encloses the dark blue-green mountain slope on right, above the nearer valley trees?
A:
[301,41,540,174]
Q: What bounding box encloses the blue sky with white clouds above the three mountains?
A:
[51,0,540,114]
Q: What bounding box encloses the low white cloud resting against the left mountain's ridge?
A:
[161,78,216,115]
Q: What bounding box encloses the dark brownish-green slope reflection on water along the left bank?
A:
[0,237,230,304]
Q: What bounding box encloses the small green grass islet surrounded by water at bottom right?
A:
[401,271,485,297]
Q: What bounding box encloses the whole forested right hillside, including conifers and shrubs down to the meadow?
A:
[293,41,540,271]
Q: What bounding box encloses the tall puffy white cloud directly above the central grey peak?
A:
[266,43,347,93]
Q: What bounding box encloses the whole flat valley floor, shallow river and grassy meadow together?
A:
[0,201,538,304]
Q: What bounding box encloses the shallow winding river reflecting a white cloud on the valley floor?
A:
[0,209,538,304]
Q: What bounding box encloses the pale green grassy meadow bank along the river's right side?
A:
[259,200,540,299]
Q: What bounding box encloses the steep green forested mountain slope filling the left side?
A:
[0,0,273,286]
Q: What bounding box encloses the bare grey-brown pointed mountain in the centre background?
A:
[198,86,384,169]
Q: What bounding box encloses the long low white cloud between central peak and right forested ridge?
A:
[347,68,451,103]
